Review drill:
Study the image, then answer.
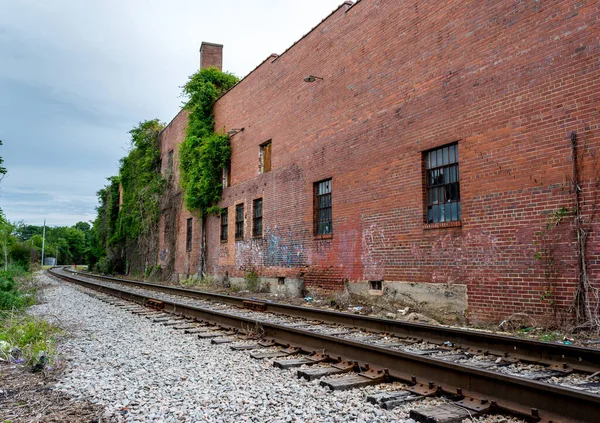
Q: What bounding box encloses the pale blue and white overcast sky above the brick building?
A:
[0,0,343,226]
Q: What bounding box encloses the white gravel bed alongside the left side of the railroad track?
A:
[34,276,458,422]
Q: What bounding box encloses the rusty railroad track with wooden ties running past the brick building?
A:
[50,270,600,422]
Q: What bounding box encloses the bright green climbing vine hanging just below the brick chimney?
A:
[179,68,238,216]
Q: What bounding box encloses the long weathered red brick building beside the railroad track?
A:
[161,0,600,319]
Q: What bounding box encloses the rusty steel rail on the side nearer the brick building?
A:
[62,270,600,373]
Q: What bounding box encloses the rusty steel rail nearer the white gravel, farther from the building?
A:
[50,271,600,422]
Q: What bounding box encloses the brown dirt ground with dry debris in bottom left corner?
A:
[0,362,113,423]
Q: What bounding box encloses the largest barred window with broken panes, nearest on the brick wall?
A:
[425,143,461,223]
